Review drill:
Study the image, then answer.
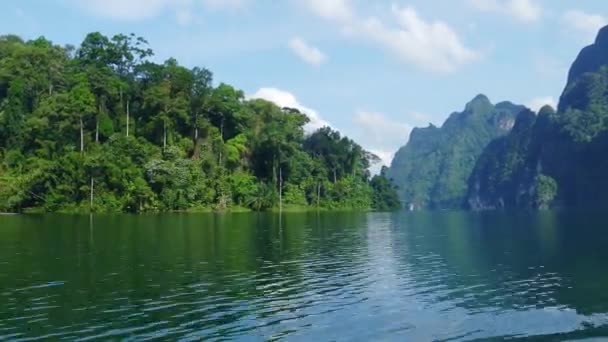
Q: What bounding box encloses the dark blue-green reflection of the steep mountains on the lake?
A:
[395,212,608,314]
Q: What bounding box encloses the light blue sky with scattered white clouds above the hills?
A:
[0,0,608,166]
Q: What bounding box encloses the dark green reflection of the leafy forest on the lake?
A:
[0,213,364,336]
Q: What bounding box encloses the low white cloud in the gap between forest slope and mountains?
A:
[352,111,412,166]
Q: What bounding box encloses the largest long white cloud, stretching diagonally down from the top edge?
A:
[306,0,480,72]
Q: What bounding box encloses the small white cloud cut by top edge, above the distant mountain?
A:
[468,0,543,22]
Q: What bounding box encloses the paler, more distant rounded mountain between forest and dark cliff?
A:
[388,95,524,209]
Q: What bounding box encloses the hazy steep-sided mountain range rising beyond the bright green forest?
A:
[388,27,608,210]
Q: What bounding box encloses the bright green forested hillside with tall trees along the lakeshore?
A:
[0,33,401,212]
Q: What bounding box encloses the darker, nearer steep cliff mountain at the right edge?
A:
[467,27,608,209]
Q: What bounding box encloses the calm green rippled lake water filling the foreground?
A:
[0,212,608,341]
